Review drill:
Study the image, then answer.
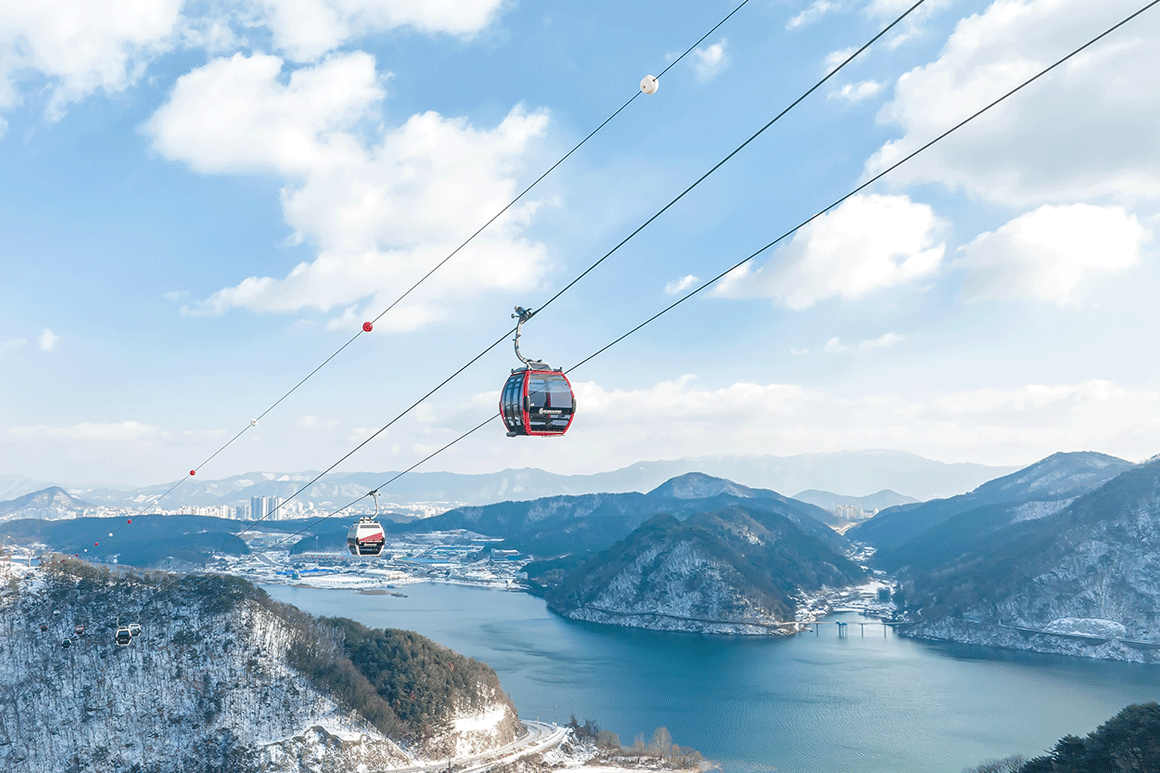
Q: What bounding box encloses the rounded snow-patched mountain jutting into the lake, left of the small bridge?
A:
[527,506,863,634]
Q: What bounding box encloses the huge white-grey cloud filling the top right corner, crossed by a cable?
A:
[867,0,1160,207]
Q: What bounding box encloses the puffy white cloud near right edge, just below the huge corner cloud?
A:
[955,204,1150,306]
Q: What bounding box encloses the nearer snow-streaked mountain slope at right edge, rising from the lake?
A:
[906,462,1160,663]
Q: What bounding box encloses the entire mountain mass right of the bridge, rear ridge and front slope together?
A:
[847,453,1160,663]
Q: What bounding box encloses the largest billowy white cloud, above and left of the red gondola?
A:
[146,52,548,330]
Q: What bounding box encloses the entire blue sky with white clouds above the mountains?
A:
[0,0,1160,485]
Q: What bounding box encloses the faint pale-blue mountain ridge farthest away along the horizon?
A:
[0,450,1014,507]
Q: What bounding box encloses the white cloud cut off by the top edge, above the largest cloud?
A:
[255,0,503,62]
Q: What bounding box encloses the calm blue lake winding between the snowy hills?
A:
[266,584,1160,773]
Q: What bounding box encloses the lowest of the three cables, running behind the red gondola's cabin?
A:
[230,0,1160,555]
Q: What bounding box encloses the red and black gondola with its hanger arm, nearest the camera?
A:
[500,306,577,438]
